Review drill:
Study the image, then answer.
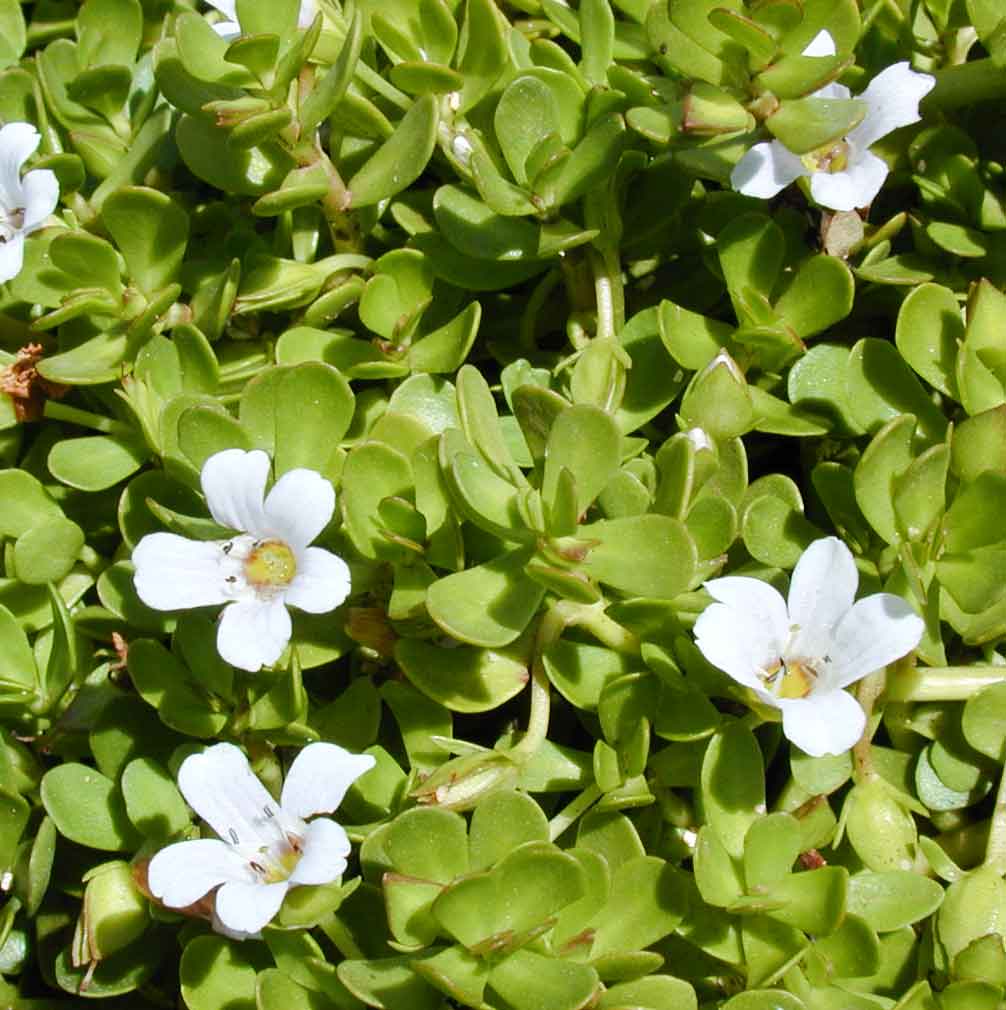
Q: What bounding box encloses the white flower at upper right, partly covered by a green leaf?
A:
[730,31,936,210]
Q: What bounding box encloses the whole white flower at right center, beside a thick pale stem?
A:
[695,536,924,758]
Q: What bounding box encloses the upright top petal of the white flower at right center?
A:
[786,536,860,659]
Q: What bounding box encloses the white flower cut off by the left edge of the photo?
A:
[0,123,60,284]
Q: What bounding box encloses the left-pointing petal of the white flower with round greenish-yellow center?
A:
[132,533,228,610]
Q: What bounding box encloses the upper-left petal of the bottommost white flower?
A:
[178,743,280,850]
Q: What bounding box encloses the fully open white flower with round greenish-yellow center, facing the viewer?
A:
[132,448,349,672]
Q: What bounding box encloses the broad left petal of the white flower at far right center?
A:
[694,576,789,689]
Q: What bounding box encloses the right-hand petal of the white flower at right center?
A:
[829,593,925,687]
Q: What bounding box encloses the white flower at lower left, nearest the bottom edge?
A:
[146,743,375,938]
